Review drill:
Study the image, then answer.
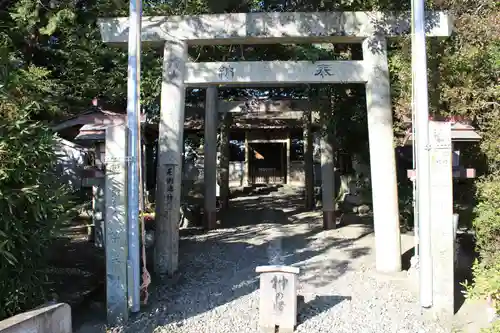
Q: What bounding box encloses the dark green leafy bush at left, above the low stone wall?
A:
[0,114,73,319]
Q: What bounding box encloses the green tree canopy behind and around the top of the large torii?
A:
[0,0,500,324]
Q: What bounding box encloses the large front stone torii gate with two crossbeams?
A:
[98,12,452,274]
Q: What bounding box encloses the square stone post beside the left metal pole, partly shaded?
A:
[105,125,128,325]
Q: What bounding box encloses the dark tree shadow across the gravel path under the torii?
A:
[73,185,373,333]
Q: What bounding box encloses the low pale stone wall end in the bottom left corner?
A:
[0,303,72,333]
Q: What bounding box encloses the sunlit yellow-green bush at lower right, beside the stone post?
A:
[468,173,500,313]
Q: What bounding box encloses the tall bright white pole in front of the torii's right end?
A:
[411,0,433,308]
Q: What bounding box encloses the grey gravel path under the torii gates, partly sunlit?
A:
[80,187,444,333]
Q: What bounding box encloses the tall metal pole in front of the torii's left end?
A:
[127,0,142,312]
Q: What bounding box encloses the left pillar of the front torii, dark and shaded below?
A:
[154,40,187,275]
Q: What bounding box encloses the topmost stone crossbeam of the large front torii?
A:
[98,12,453,45]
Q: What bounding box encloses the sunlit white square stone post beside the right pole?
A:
[429,121,455,322]
